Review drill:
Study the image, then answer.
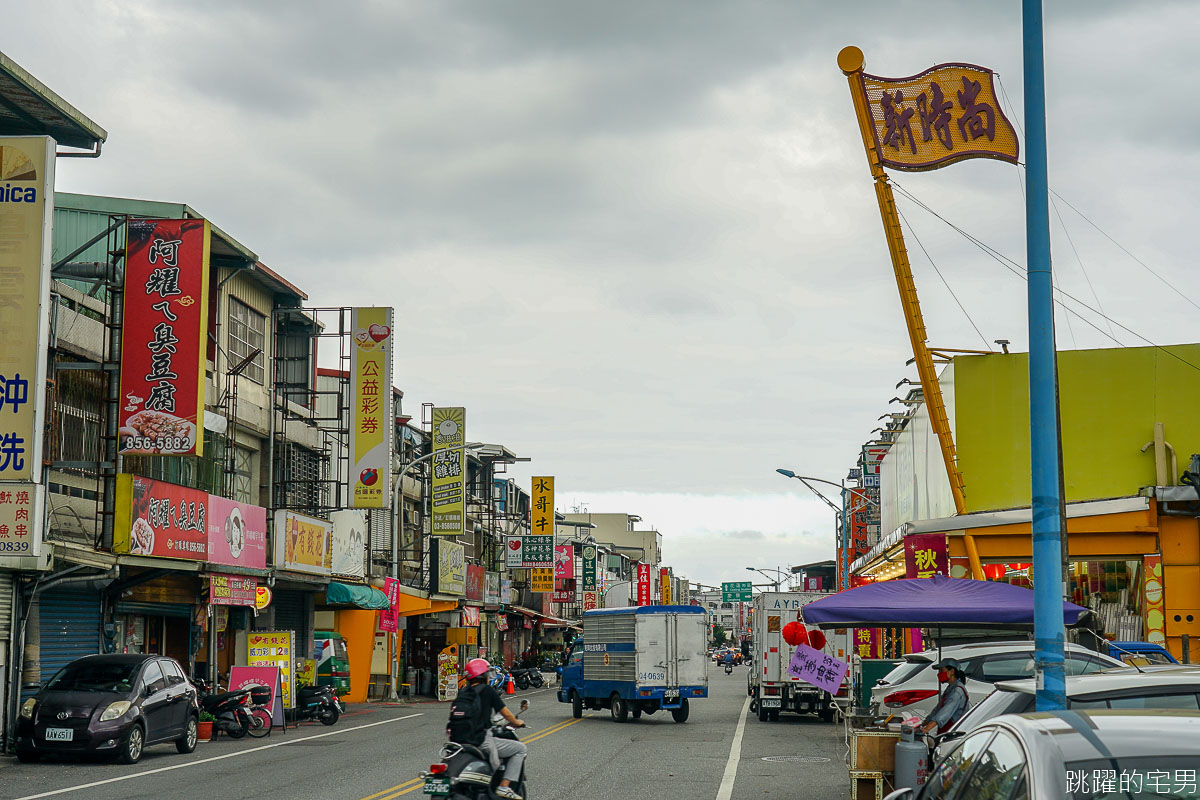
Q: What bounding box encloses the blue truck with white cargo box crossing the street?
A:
[558,606,708,722]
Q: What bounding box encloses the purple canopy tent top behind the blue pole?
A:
[803,576,1091,630]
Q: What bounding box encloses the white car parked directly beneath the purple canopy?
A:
[871,640,1126,718]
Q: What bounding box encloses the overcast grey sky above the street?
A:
[11,0,1200,583]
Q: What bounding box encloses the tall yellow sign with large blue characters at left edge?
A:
[0,137,55,482]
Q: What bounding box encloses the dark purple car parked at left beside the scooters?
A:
[17,655,200,764]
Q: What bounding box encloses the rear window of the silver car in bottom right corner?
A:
[1066,756,1200,800]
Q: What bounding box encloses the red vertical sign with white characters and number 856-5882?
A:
[119,219,209,456]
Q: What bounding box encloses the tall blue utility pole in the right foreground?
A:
[1021,0,1067,711]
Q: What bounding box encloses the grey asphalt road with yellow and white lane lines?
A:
[0,667,848,800]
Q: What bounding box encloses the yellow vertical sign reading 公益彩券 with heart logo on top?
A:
[350,308,395,509]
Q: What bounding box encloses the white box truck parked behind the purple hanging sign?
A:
[746,591,850,722]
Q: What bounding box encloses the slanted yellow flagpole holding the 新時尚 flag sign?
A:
[838,46,984,581]
